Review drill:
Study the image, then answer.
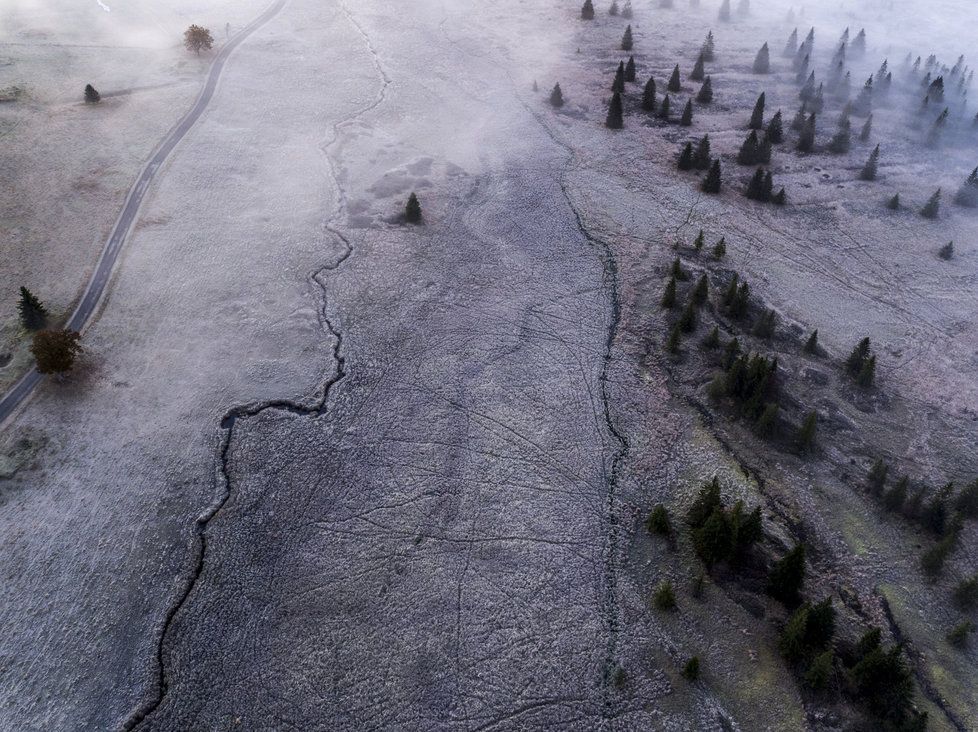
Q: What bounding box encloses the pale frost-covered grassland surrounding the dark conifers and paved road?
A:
[0,0,978,730]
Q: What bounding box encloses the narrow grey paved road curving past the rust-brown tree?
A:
[0,0,288,427]
